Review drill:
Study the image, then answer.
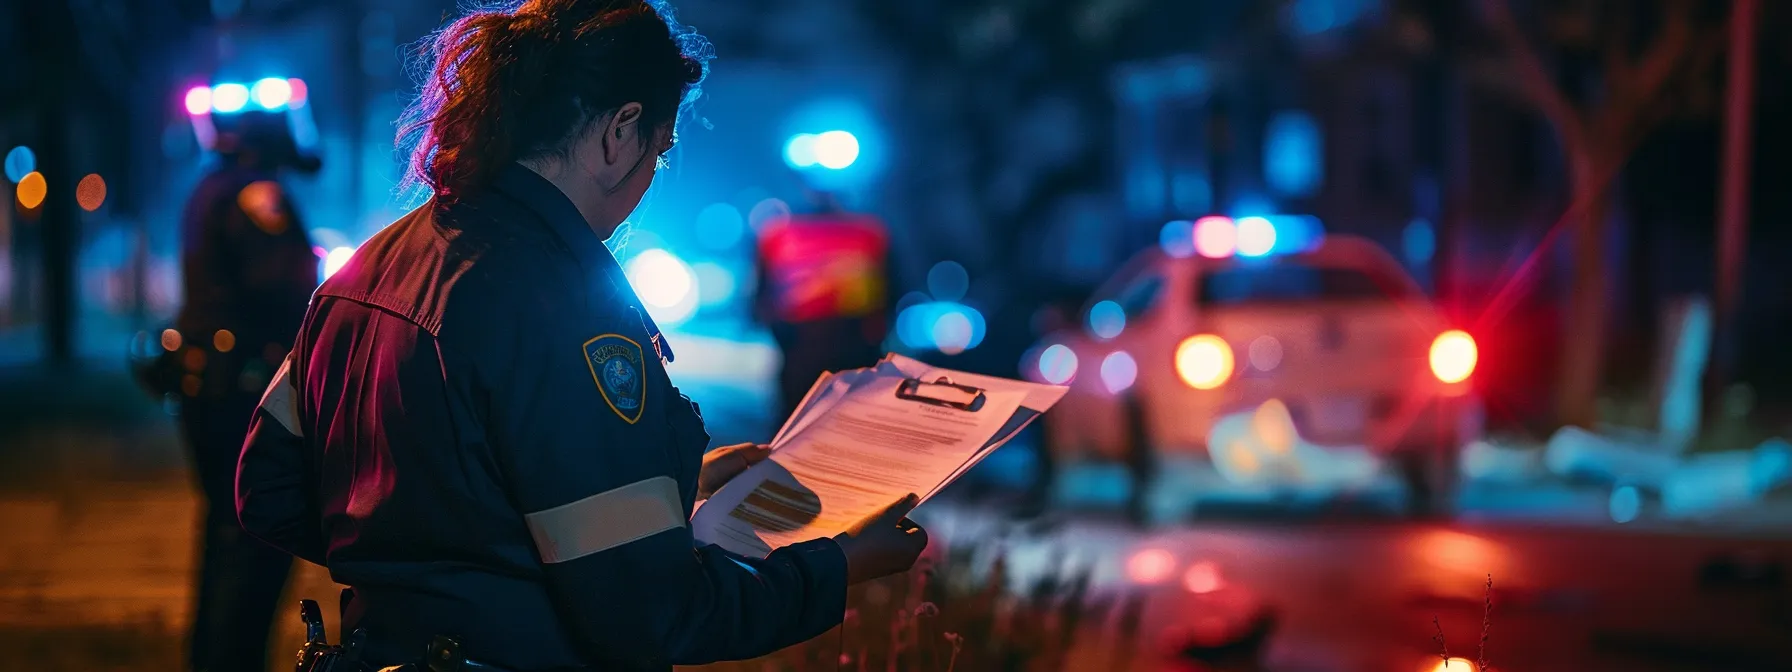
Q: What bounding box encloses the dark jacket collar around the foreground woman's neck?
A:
[491,163,672,362]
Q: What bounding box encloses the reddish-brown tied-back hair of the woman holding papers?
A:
[398,0,710,201]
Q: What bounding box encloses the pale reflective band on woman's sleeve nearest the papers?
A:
[523,477,685,563]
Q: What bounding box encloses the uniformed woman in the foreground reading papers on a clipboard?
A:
[237,0,926,670]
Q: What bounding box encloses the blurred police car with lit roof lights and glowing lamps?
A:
[1021,217,1480,511]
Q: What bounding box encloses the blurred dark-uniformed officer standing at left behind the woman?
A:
[174,102,319,672]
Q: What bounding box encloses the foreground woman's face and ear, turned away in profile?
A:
[573,102,672,238]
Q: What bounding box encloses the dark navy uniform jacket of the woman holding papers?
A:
[237,165,846,670]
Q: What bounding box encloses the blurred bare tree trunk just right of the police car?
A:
[1555,161,1611,428]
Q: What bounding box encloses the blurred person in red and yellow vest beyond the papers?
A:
[754,190,891,418]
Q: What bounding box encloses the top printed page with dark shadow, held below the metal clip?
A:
[692,376,1025,557]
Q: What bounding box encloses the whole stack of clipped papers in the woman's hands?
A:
[692,355,1068,557]
